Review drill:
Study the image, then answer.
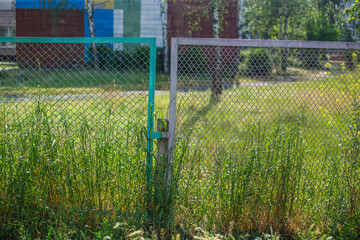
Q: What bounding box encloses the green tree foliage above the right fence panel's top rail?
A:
[245,0,345,41]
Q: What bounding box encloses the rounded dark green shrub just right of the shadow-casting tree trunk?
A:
[246,49,273,76]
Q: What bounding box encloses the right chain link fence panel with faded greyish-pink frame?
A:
[170,39,360,236]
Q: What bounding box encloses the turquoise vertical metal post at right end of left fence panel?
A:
[146,38,156,210]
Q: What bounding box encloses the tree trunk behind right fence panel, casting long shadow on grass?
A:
[210,0,223,100]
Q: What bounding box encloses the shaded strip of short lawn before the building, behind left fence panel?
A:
[0,68,169,99]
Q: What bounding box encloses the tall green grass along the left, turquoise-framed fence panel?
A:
[0,99,146,239]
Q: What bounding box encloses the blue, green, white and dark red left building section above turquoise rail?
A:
[16,0,162,45]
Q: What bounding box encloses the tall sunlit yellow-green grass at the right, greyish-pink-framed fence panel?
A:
[169,72,360,239]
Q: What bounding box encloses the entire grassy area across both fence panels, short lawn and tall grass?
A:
[0,66,360,239]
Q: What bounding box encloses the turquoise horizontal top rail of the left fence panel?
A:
[0,37,156,44]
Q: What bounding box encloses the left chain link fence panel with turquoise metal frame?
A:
[0,38,156,229]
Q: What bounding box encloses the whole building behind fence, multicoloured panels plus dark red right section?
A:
[15,0,237,46]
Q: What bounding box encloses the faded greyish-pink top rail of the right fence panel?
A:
[172,38,360,50]
